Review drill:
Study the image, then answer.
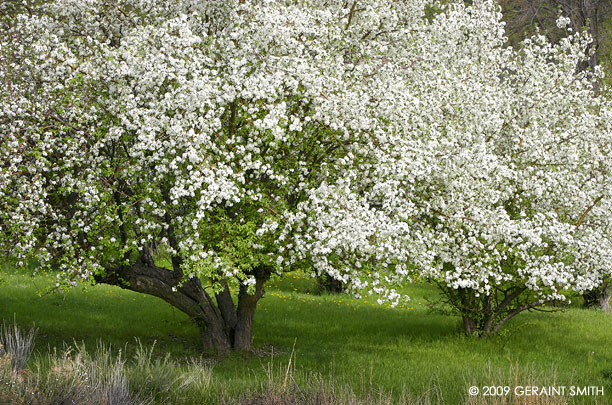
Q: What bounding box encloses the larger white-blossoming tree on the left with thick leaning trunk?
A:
[0,0,392,350]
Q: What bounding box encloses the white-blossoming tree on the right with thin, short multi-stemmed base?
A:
[286,2,612,335]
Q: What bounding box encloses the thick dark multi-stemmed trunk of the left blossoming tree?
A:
[95,263,270,352]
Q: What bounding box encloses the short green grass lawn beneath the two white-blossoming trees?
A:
[0,266,612,404]
